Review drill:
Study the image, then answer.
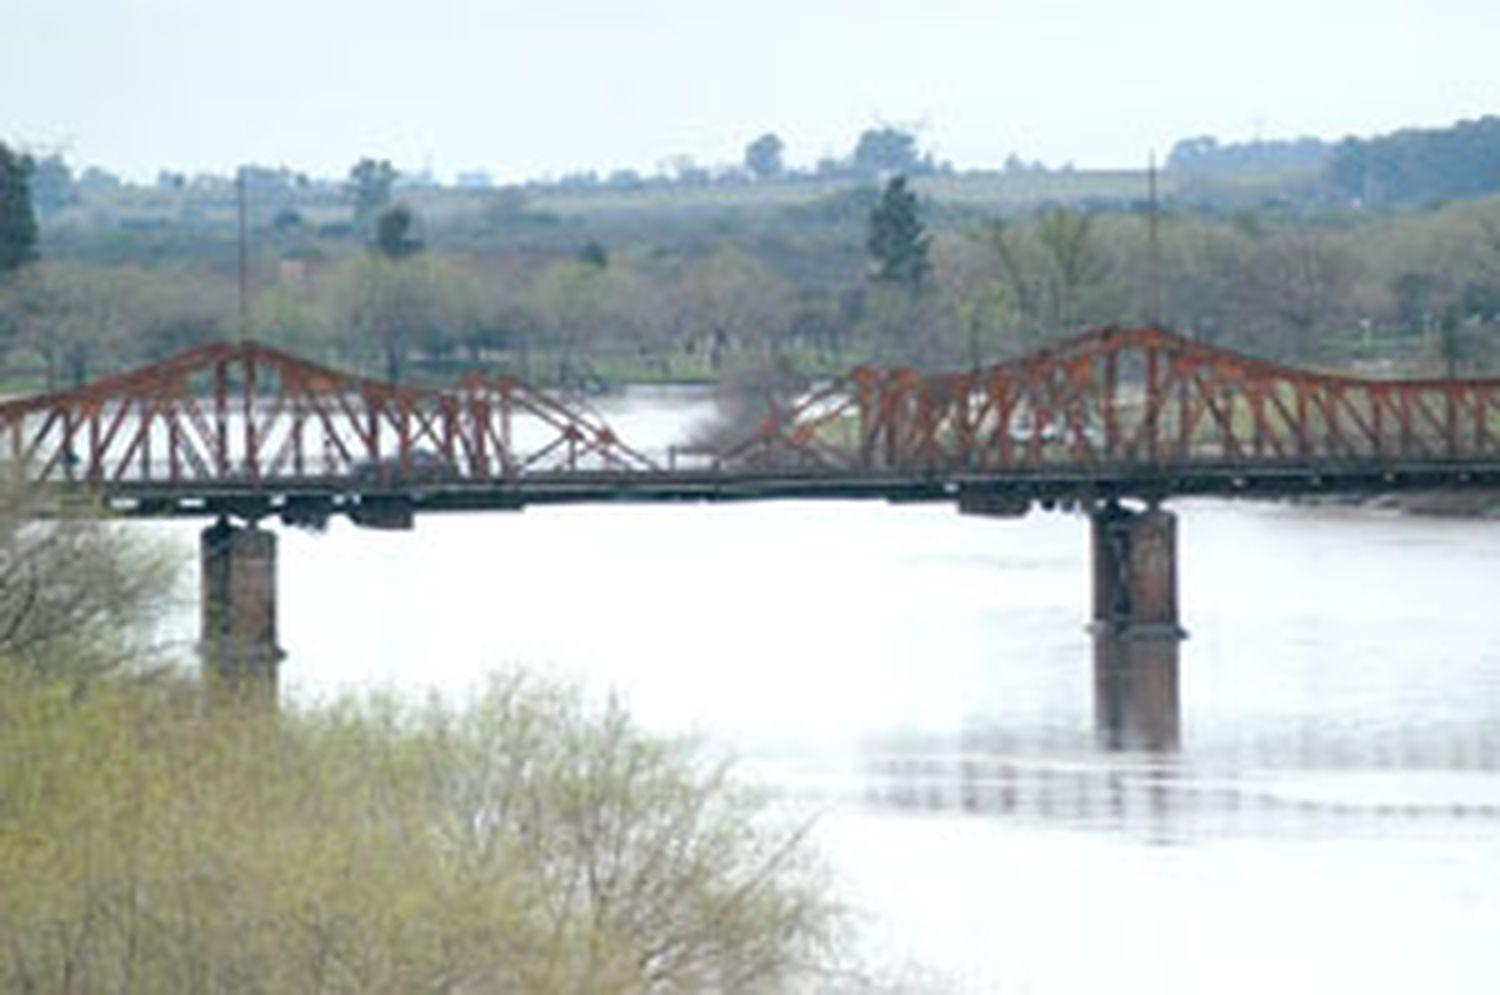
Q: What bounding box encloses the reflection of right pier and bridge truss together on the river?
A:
[861,615,1500,842]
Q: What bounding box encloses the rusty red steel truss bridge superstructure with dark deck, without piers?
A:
[0,327,1500,527]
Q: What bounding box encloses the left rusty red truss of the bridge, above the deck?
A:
[0,342,653,488]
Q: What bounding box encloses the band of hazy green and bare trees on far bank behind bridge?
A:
[0,186,1500,384]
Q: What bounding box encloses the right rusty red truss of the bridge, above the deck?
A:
[725,329,1500,474]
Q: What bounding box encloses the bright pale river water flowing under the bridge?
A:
[146,393,1500,995]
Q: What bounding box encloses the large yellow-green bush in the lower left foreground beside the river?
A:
[0,674,836,995]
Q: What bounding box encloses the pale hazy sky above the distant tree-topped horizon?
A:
[0,0,1500,180]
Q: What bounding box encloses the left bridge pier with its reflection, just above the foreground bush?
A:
[198,518,285,708]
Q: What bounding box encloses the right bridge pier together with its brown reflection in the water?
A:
[1091,503,1187,750]
